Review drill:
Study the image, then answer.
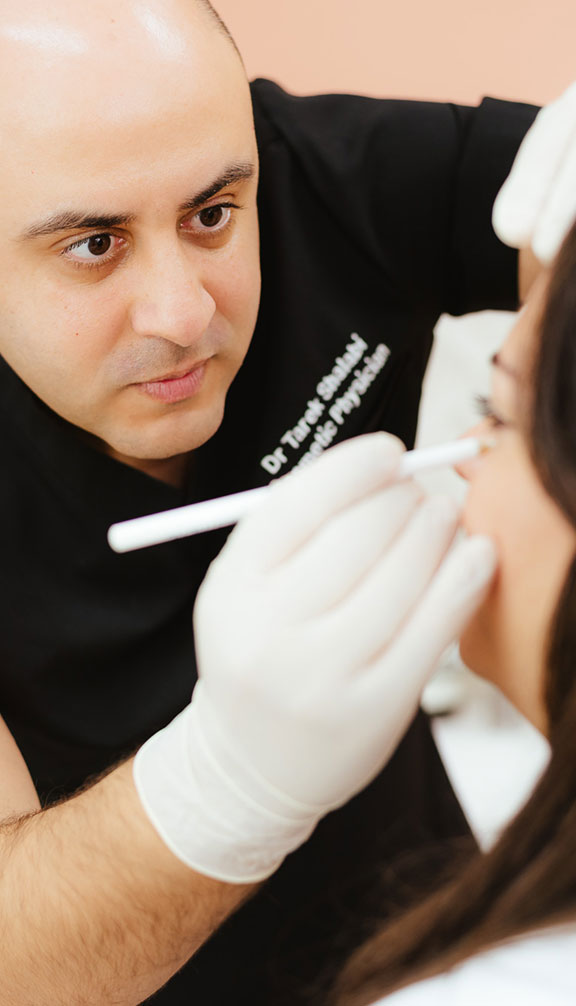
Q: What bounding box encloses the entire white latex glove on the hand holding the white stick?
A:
[135,434,496,882]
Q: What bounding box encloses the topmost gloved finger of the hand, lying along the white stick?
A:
[220,433,404,568]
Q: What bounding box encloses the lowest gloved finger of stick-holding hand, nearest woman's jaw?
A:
[365,535,498,694]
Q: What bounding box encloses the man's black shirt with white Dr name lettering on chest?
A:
[0,80,536,1006]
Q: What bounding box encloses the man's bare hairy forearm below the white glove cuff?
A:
[0,763,252,1006]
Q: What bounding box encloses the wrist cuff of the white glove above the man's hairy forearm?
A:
[134,683,327,883]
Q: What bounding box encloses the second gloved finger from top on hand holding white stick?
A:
[270,480,423,618]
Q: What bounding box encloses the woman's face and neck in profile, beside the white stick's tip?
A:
[458,280,576,732]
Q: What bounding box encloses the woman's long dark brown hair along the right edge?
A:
[332,227,576,1006]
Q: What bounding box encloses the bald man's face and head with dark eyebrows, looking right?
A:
[0,0,259,461]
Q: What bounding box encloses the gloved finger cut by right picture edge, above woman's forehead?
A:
[532,135,576,265]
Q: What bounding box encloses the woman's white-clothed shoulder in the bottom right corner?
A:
[371,926,576,1006]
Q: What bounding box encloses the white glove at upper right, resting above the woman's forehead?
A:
[493,83,576,265]
